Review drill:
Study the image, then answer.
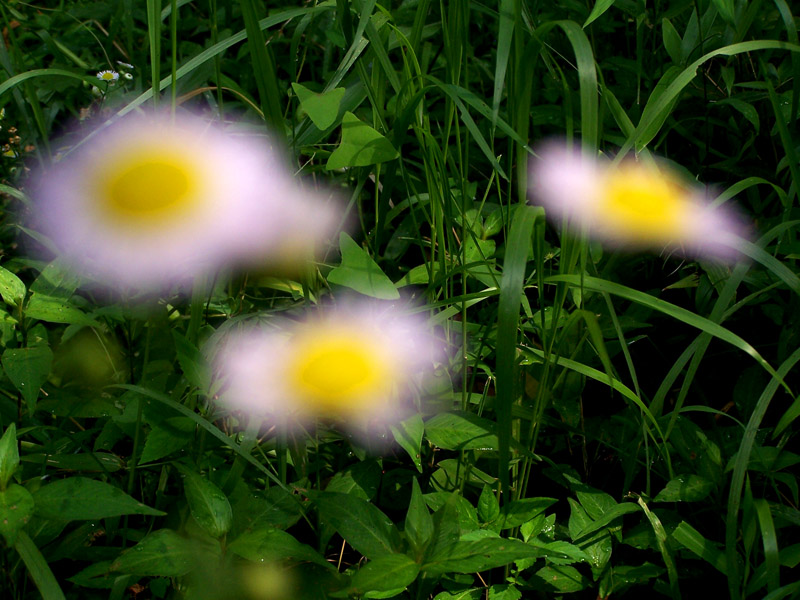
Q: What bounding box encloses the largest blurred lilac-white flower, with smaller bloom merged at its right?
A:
[34,114,334,289]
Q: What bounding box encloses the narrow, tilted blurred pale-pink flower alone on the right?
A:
[529,142,744,259]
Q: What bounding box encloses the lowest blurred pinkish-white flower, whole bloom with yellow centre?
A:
[214,303,441,431]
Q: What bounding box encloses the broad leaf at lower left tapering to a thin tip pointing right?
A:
[33,477,165,521]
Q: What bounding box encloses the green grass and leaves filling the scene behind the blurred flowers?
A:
[0,0,800,600]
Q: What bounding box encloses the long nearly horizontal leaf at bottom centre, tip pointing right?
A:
[422,538,539,576]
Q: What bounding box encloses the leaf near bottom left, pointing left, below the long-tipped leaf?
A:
[111,529,197,577]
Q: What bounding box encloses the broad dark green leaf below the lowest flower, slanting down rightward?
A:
[311,492,400,559]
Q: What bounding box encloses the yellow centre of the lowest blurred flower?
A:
[288,327,393,416]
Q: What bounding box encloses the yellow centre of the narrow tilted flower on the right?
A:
[598,165,688,241]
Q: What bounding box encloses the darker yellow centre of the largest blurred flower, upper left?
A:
[96,148,201,226]
